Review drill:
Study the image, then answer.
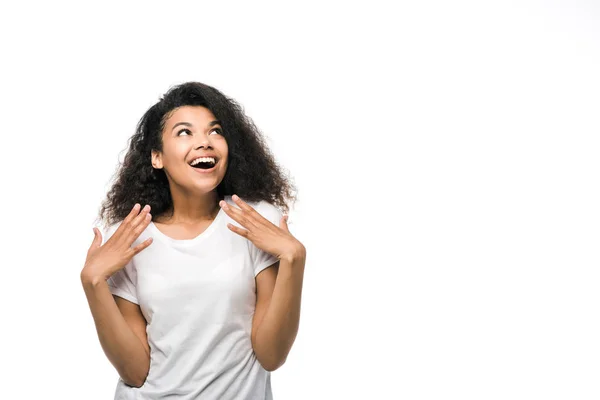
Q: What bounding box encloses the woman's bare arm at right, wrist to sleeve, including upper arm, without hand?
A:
[252,247,306,371]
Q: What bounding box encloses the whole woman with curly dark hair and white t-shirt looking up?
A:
[81,82,306,400]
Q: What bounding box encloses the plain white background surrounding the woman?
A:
[0,0,600,400]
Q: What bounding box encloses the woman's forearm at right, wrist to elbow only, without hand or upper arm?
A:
[254,254,306,370]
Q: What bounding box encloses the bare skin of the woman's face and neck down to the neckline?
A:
[152,106,228,234]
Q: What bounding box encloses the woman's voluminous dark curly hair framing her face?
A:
[98,82,296,226]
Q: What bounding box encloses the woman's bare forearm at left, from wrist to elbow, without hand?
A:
[81,275,150,386]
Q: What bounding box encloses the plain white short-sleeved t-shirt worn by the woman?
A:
[103,196,282,400]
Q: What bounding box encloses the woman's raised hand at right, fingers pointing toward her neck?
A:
[219,194,306,260]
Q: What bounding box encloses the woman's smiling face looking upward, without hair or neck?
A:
[152,106,228,193]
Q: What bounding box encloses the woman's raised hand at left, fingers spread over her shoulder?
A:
[81,204,152,280]
